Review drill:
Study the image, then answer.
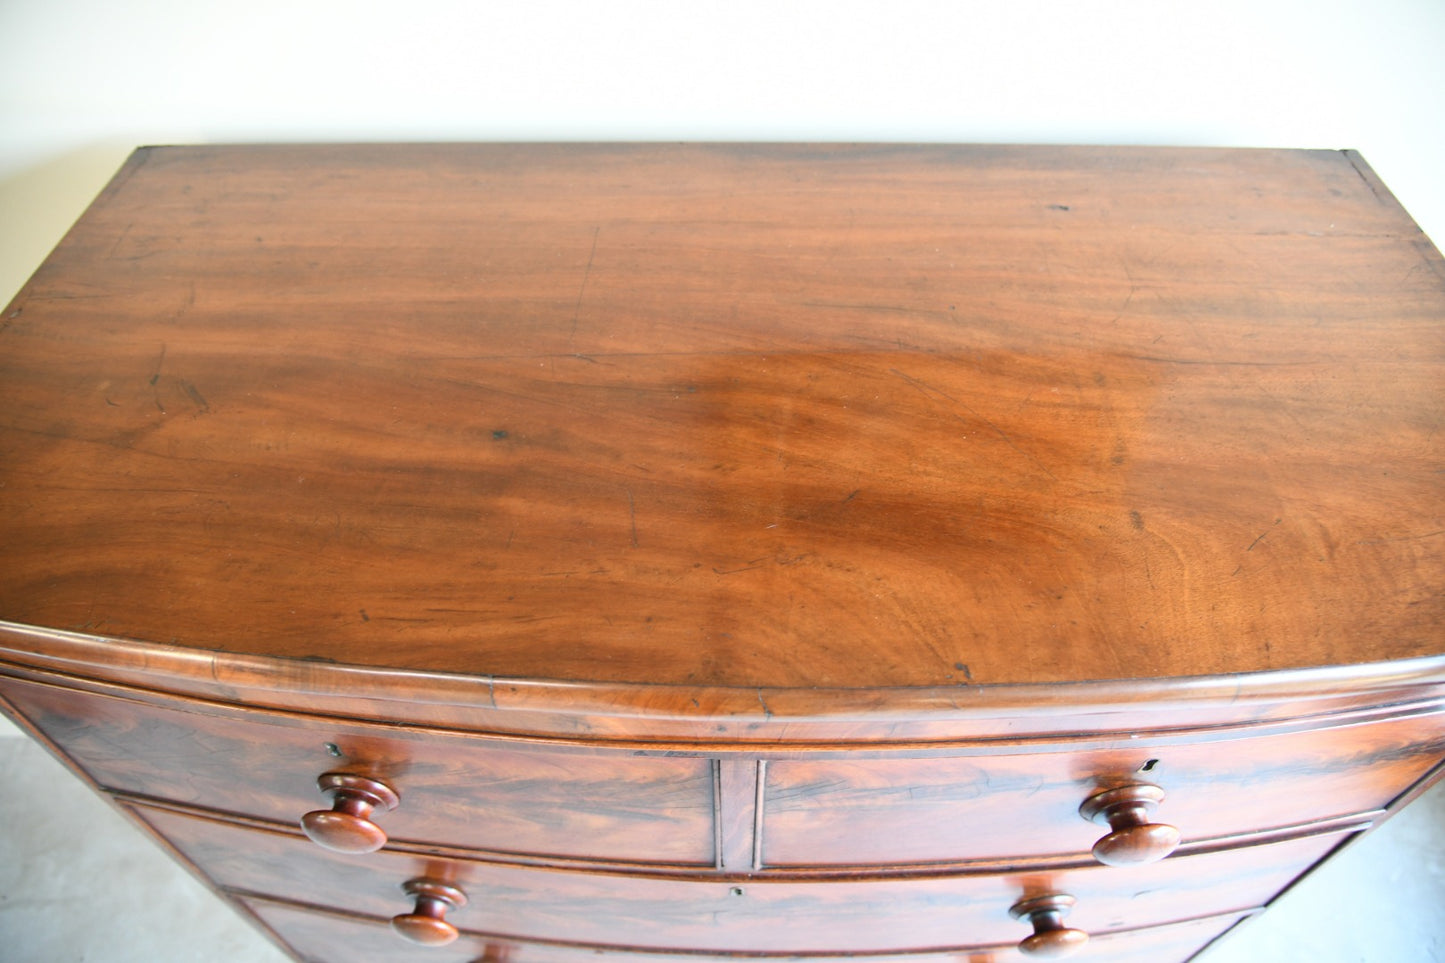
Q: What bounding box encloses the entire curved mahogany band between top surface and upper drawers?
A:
[0,622,1445,746]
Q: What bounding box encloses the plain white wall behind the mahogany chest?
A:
[0,0,1445,298]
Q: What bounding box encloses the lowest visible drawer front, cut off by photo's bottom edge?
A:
[241,899,1240,963]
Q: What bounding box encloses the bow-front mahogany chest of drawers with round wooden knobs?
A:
[0,138,1445,963]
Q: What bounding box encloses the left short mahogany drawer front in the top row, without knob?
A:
[0,678,714,868]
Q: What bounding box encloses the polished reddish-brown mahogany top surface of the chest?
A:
[0,145,1445,688]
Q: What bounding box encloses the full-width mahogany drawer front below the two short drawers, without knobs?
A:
[140,808,1341,954]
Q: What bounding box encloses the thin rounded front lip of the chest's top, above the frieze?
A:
[0,620,1445,723]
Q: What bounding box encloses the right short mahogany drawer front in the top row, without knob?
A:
[762,713,1445,868]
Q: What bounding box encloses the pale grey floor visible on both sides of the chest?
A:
[0,719,1445,963]
